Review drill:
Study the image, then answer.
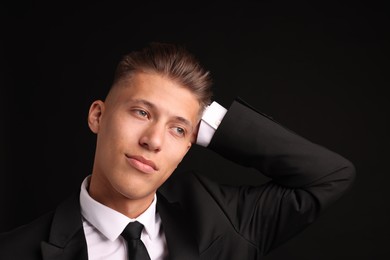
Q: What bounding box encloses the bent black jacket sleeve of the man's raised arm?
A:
[209,100,355,255]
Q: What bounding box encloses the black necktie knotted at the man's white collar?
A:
[121,221,150,260]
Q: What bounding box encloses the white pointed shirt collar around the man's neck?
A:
[80,175,159,241]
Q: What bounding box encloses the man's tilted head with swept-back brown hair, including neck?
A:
[88,44,211,217]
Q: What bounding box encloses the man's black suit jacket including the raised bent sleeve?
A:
[0,100,355,260]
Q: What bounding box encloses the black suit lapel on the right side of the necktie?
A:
[157,193,199,260]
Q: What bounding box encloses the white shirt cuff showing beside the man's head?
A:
[196,101,227,147]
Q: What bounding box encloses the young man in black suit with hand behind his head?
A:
[0,43,355,260]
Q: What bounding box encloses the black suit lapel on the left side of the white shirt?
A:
[41,193,88,260]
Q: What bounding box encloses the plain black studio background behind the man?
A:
[0,0,390,260]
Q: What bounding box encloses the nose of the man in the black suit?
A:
[139,123,164,152]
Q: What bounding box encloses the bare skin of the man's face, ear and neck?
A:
[88,72,200,218]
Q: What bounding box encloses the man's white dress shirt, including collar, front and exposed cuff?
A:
[80,101,227,260]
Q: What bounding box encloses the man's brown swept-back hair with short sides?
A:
[109,42,212,111]
